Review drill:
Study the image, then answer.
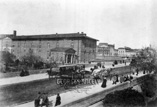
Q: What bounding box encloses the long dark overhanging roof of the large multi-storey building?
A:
[11,33,98,41]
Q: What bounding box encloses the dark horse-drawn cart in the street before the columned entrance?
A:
[47,64,84,88]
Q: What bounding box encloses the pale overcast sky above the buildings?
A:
[0,0,157,48]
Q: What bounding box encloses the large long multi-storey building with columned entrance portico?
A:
[3,32,98,63]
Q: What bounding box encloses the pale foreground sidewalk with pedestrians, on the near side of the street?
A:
[16,67,143,107]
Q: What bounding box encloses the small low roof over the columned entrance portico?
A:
[51,47,76,53]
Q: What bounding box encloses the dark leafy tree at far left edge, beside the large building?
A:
[1,51,16,70]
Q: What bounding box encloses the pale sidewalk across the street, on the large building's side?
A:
[0,64,128,86]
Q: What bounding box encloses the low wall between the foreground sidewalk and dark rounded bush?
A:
[63,75,148,107]
